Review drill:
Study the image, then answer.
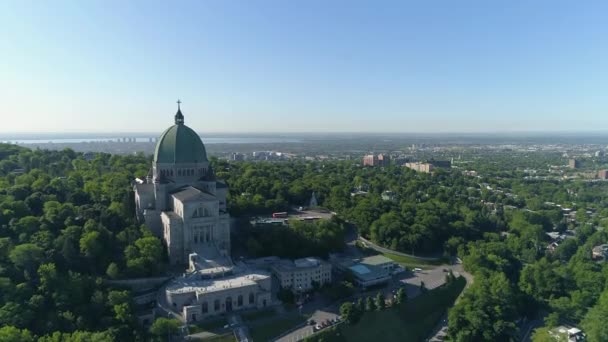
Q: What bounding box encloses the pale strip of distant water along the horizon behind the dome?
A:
[8,137,302,145]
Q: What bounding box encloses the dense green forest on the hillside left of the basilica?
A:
[0,145,165,341]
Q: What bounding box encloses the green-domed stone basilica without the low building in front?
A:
[135,101,230,265]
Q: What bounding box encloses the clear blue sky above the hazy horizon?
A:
[0,0,608,132]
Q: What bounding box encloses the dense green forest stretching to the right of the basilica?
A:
[218,155,608,341]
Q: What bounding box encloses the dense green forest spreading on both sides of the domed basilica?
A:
[0,145,608,341]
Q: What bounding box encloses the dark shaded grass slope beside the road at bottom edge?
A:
[306,278,466,342]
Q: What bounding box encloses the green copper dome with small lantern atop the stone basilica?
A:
[154,108,207,164]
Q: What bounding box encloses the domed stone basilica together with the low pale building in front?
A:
[134,101,272,322]
